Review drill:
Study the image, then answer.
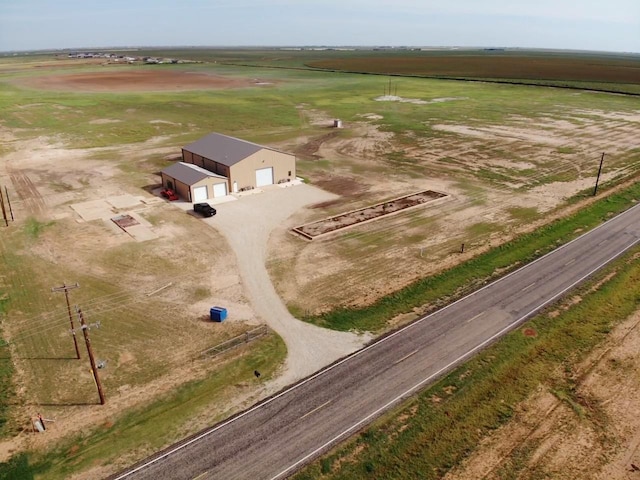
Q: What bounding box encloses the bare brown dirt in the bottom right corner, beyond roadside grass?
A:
[445,313,640,480]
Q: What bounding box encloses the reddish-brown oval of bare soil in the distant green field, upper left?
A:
[15,67,256,92]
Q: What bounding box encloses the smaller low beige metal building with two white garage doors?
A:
[161,162,228,203]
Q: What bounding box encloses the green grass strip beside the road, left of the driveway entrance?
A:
[0,334,286,480]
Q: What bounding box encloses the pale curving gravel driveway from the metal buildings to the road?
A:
[205,184,371,387]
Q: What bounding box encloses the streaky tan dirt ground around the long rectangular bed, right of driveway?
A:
[270,104,637,314]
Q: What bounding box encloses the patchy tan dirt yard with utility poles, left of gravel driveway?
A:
[0,128,266,464]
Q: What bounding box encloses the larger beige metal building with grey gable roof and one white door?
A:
[182,133,296,193]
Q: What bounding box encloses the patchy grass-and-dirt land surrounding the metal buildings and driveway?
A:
[0,50,640,478]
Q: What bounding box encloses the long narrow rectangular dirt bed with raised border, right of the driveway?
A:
[292,190,447,240]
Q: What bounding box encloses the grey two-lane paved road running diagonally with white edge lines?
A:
[113,205,640,480]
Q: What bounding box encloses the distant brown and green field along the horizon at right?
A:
[115,48,640,94]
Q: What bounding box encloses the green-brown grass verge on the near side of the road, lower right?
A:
[294,248,640,480]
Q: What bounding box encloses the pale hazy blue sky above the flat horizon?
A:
[0,0,640,53]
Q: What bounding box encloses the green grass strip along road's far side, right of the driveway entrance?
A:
[305,178,640,331]
